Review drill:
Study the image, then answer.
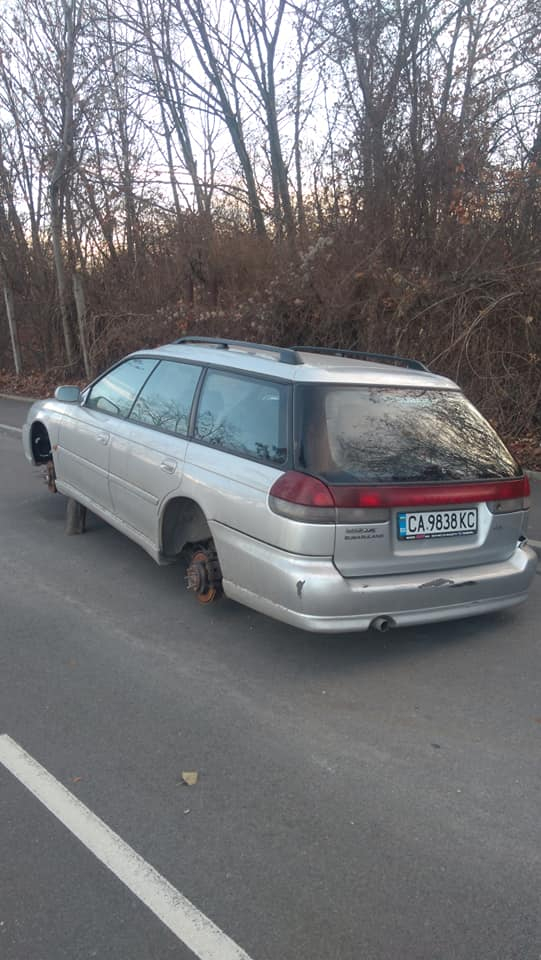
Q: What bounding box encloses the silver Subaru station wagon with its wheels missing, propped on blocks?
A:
[23,337,537,632]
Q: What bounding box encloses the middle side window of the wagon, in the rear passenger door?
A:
[130,360,201,436]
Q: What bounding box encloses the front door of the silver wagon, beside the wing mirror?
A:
[55,357,157,511]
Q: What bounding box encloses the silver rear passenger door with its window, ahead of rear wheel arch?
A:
[109,360,201,546]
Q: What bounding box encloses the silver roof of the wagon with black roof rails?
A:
[137,343,458,390]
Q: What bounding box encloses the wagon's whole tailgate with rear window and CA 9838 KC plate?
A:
[297,385,527,577]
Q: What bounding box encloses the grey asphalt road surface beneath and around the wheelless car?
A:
[0,400,541,960]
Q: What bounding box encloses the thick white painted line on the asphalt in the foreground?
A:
[0,734,250,960]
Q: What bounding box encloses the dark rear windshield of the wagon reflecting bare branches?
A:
[295,384,521,483]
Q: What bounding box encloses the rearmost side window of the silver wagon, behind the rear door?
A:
[195,371,288,464]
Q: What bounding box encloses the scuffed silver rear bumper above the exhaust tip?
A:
[211,523,537,633]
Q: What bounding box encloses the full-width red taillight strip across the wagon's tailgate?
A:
[269,470,530,523]
